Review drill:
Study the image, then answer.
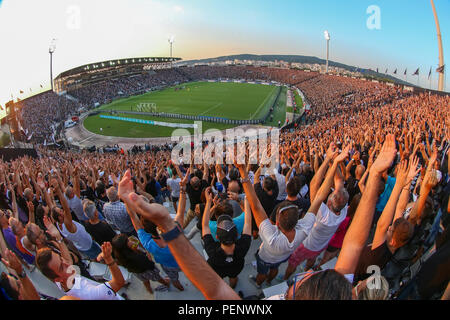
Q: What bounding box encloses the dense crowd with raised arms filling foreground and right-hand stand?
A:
[0,68,450,300]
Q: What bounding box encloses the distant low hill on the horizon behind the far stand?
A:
[184,54,414,86]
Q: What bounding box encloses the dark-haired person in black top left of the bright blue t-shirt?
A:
[111,233,170,294]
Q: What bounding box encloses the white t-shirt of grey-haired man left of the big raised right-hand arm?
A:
[303,203,348,251]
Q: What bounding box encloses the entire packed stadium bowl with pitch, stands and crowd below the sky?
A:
[0,1,450,306]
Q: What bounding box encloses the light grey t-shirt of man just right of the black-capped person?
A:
[258,212,316,263]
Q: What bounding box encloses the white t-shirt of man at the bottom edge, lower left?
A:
[56,275,125,300]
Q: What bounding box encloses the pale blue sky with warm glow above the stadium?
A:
[0,0,450,116]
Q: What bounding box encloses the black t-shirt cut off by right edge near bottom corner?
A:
[417,241,450,300]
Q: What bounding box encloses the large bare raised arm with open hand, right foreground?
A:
[335,134,397,274]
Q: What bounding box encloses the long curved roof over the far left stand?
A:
[56,57,181,79]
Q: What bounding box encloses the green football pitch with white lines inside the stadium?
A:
[84,82,286,138]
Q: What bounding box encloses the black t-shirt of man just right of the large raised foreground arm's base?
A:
[353,241,392,284]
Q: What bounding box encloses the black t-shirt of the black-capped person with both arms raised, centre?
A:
[203,234,252,278]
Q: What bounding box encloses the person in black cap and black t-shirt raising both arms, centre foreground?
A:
[202,187,252,288]
